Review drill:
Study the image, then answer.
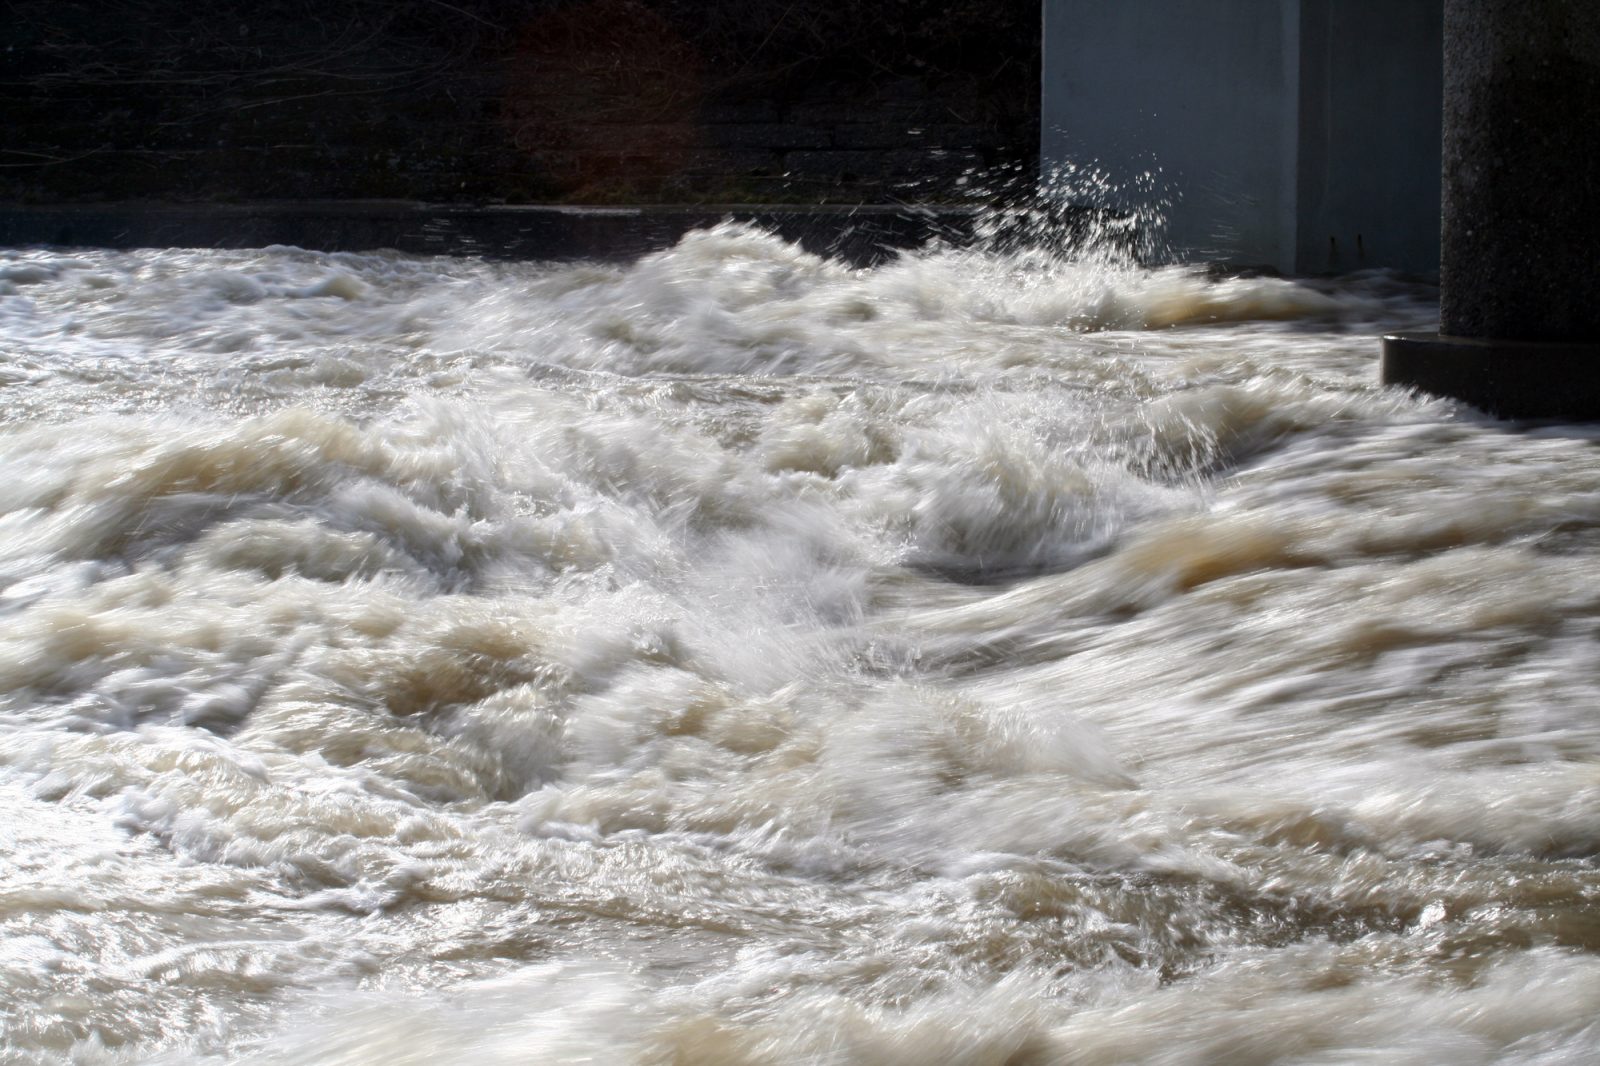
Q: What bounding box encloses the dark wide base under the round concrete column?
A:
[1378,333,1600,421]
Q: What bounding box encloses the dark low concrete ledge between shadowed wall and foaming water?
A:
[0,200,976,266]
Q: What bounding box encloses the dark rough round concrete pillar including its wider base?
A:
[1381,0,1600,419]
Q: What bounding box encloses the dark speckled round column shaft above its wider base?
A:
[1440,0,1600,341]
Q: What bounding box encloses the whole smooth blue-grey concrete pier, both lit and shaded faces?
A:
[1042,0,1443,275]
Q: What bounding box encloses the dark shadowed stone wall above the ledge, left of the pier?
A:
[0,0,1038,203]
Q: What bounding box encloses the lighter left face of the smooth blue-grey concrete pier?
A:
[1040,0,1298,269]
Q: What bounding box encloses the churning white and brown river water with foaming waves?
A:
[0,226,1600,1066]
